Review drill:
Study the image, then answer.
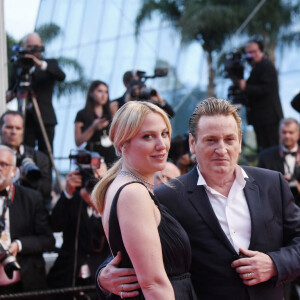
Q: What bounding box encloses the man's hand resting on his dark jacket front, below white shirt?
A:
[231,248,277,286]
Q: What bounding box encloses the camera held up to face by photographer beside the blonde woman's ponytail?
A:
[69,150,101,189]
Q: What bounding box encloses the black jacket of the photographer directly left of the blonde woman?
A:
[48,192,109,288]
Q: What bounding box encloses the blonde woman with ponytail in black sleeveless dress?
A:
[92,101,196,300]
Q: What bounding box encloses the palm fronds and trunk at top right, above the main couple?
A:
[136,0,300,96]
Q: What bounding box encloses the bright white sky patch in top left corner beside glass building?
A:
[4,0,40,40]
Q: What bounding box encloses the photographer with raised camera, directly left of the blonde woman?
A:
[48,152,109,300]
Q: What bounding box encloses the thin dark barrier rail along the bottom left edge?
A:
[0,285,96,300]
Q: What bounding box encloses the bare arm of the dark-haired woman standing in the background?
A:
[75,118,109,146]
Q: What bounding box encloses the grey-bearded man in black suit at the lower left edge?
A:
[0,145,55,294]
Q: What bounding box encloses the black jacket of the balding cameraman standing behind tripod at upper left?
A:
[9,59,66,126]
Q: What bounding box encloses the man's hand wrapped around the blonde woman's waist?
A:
[97,252,140,298]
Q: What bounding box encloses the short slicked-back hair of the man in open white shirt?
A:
[189,97,242,141]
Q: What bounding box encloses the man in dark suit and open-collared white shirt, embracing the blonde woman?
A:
[97,98,300,300]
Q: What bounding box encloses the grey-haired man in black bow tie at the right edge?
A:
[258,118,300,206]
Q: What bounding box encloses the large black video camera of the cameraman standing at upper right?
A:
[224,50,252,104]
